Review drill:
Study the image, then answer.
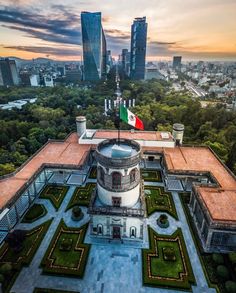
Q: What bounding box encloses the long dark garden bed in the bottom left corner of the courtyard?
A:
[0,220,52,292]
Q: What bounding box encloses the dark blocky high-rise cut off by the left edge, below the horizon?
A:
[0,58,19,86]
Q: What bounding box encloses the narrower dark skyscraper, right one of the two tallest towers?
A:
[130,17,147,79]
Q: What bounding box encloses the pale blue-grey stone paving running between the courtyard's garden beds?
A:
[11,182,215,293]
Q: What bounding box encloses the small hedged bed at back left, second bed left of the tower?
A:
[40,184,69,210]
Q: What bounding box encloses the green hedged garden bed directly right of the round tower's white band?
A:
[144,186,178,219]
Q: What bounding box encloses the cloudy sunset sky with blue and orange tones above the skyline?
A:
[0,0,236,61]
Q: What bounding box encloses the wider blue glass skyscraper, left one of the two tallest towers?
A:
[81,12,107,81]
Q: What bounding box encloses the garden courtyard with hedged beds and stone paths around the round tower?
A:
[0,164,216,293]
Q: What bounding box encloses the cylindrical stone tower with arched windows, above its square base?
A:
[95,139,141,207]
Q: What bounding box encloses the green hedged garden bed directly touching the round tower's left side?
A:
[66,183,96,211]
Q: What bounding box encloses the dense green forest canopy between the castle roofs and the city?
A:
[0,75,236,175]
